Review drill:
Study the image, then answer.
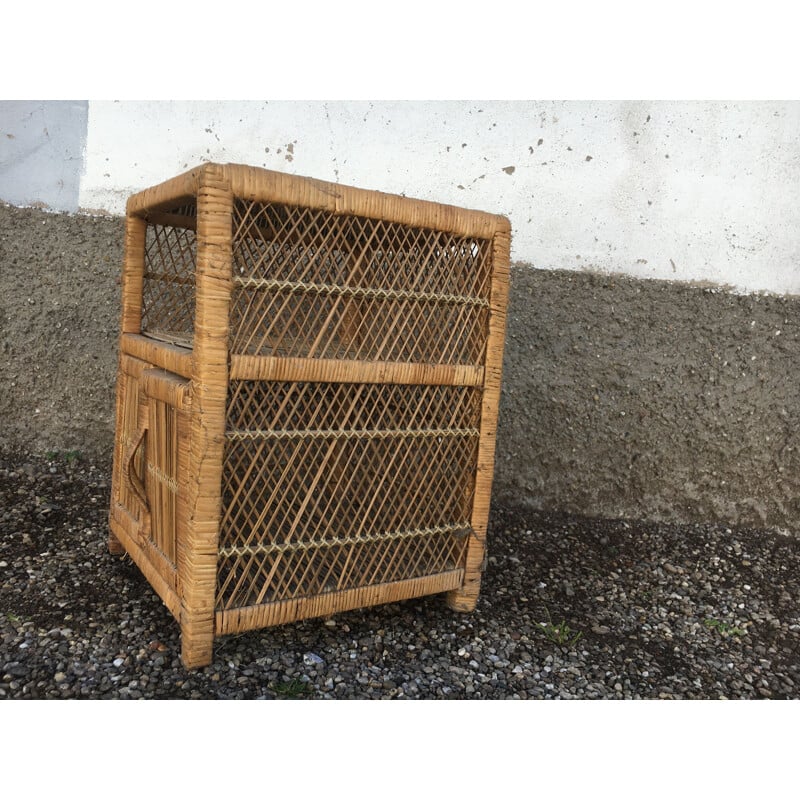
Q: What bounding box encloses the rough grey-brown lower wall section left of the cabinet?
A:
[0,206,123,458]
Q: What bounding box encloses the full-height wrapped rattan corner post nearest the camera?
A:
[178,164,233,669]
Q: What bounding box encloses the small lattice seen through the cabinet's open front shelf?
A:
[142,206,197,346]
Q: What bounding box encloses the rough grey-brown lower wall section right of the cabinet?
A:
[495,268,800,528]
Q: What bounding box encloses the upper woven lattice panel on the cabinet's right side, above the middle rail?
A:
[230,201,491,364]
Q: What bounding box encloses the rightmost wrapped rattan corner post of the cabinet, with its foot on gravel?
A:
[447,221,511,611]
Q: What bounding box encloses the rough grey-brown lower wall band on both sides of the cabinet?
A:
[0,206,800,529]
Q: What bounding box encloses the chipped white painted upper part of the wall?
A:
[50,101,800,293]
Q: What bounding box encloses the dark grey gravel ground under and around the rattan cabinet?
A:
[0,450,800,699]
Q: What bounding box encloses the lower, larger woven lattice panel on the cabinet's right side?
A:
[217,381,481,609]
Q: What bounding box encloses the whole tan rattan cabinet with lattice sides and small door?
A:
[109,159,510,667]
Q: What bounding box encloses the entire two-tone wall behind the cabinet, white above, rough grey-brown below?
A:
[0,103,800,530]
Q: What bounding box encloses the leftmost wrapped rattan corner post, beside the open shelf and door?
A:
[108,212,147,555]
